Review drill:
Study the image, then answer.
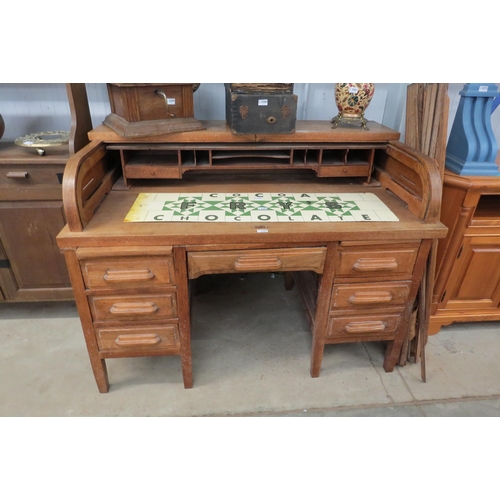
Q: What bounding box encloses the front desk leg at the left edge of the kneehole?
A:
[173,247,193,389]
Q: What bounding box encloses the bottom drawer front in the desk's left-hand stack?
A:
[96,324,180,354]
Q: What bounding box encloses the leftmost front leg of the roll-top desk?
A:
[64,249,109,393]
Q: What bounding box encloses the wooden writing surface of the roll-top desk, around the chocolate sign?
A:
[58,175,446,246]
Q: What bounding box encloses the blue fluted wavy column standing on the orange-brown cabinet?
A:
[446,83,500,175]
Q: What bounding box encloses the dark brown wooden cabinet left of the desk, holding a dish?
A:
[0,144,73,301]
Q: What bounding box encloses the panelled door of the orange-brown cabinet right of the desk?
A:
[446,236,500,309]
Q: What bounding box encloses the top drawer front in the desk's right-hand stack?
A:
[337,246,418,279]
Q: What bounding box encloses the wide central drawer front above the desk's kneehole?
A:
[188,247,326,278]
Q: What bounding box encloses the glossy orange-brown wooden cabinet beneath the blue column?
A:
[429,172,500,334]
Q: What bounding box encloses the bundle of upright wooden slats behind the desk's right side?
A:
[400,83,450,376]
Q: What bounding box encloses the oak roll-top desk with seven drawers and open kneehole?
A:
[57,121,447,392]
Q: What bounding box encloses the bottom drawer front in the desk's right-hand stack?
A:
[327,314,400,342]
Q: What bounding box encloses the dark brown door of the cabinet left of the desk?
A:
[0,201,72,300]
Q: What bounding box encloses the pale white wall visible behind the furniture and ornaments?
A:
[0,83,500,148]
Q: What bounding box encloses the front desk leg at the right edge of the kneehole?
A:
[310,243,337,378]
